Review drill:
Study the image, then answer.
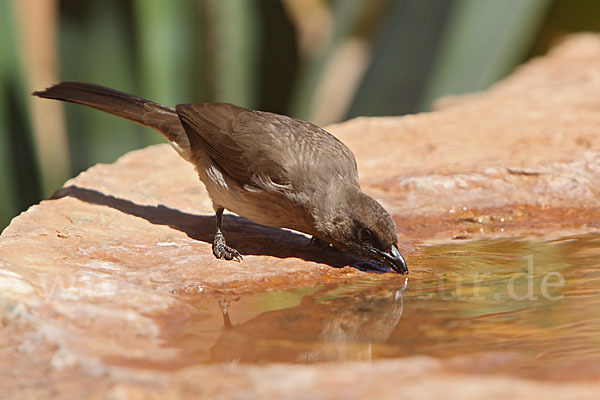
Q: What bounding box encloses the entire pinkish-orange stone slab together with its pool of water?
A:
[0,35,600,399]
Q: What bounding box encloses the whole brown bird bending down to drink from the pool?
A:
[33,82,408,273]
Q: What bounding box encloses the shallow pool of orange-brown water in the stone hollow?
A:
[165,234,600,380]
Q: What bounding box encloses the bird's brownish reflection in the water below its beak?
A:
[210,278,408,363]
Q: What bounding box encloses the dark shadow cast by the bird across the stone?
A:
[51,186,390,272]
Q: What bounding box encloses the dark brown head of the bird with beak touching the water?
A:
[327,190,408,274]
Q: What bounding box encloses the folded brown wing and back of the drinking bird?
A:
[176,103,358,189]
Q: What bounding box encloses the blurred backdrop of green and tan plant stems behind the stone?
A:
[0,0,600,229]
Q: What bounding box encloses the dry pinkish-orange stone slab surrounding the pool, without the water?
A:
[0,34,600,399]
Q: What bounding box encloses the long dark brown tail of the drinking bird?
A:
[32,82,190,159]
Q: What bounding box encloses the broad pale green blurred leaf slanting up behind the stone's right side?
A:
[421,0,551,109]
